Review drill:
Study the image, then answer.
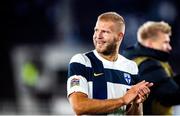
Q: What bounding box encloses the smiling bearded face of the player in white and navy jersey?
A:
[93,21,120,55]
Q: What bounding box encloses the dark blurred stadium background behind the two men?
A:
[0,0,180,114]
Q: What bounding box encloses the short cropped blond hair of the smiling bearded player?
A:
[98,12,125,33]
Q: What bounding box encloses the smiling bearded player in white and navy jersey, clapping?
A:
[67,12,153,114]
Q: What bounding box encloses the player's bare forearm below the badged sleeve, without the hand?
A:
[70,93,125,114]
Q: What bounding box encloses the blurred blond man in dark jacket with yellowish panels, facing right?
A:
[123,21,180,115]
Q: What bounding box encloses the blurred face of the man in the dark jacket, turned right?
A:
[152,32,172,53]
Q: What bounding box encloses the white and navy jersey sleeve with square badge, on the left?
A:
[67,54,88,96]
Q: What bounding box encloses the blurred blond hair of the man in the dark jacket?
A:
[137,21,171,43]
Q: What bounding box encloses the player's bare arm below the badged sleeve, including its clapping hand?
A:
[69,81,152,114]
